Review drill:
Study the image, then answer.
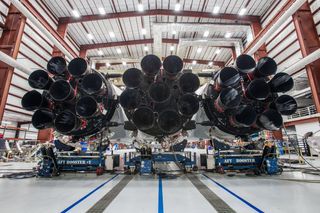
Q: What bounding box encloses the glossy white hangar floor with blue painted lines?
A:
[0,163,320,213]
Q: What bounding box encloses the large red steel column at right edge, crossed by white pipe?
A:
[293,3,320,112]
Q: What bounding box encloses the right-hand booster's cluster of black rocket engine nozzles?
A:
[199,55,297,136]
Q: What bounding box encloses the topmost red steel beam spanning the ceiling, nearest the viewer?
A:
[59,9,260,24]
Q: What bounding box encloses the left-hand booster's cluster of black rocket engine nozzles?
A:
[21,57,117,136]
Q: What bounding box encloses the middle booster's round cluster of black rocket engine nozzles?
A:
[120,55,200,137]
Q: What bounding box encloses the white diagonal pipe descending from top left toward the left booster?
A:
[11,0,74,59]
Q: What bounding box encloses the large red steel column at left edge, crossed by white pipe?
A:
[0,4,26,121]
